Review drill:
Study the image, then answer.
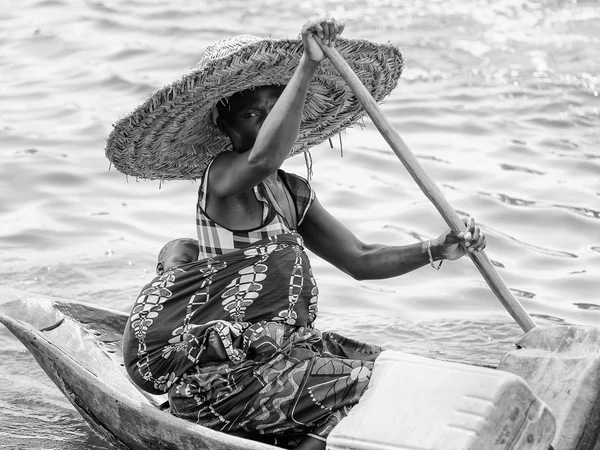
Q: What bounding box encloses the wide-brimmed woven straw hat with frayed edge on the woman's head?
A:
[106,35,403,180]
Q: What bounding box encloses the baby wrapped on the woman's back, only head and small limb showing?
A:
[156,238,229,364]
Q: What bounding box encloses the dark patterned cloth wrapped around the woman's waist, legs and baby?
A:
[123,233,381,446]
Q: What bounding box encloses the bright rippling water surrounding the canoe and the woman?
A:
[0,0,600,449]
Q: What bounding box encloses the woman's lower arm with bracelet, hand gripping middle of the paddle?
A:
[299,199,486,280]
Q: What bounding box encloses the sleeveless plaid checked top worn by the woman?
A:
[196,165,315,260]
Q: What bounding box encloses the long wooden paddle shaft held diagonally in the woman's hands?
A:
[315,36,536,332]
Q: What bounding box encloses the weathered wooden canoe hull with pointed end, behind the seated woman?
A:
[0,291,277,450]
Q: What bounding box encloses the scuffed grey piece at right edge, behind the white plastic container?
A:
[498,325,600,450]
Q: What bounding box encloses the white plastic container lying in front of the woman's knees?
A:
[327,351,555,450]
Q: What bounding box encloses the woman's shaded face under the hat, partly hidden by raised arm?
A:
[217,86,284,153]
